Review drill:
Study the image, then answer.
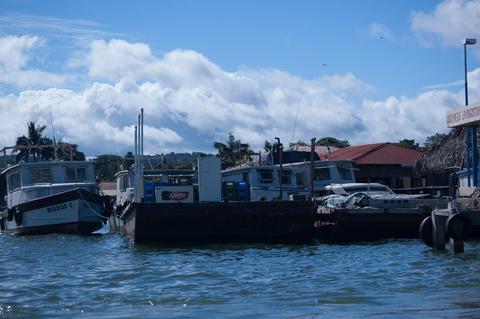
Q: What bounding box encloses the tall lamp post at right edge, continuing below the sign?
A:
[463,38,478,187]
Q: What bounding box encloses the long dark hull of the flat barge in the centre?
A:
[112,201,316,244]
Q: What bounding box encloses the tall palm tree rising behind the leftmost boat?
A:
[12,122,47,162]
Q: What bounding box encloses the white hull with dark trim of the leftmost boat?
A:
[3,189,103,235]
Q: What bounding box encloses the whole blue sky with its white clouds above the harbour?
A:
[0,0,480,156]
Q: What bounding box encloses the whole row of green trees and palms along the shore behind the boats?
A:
[5,122,447,182]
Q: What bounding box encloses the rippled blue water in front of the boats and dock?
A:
[0,234,480,318]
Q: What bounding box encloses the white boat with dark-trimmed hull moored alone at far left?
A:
[0,161,109,234]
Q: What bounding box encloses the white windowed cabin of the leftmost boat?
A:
[2,161,97,207]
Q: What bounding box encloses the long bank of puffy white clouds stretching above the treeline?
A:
[0,40,472,154]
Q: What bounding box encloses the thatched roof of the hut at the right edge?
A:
[415,128,466,176]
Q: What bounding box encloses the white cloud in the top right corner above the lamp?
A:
[411,0,480,46]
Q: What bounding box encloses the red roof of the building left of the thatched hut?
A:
[329,143,422,165]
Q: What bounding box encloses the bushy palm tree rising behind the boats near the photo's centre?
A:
[213,132,253,169]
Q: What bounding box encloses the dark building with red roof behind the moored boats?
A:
[321,143,425,189]
